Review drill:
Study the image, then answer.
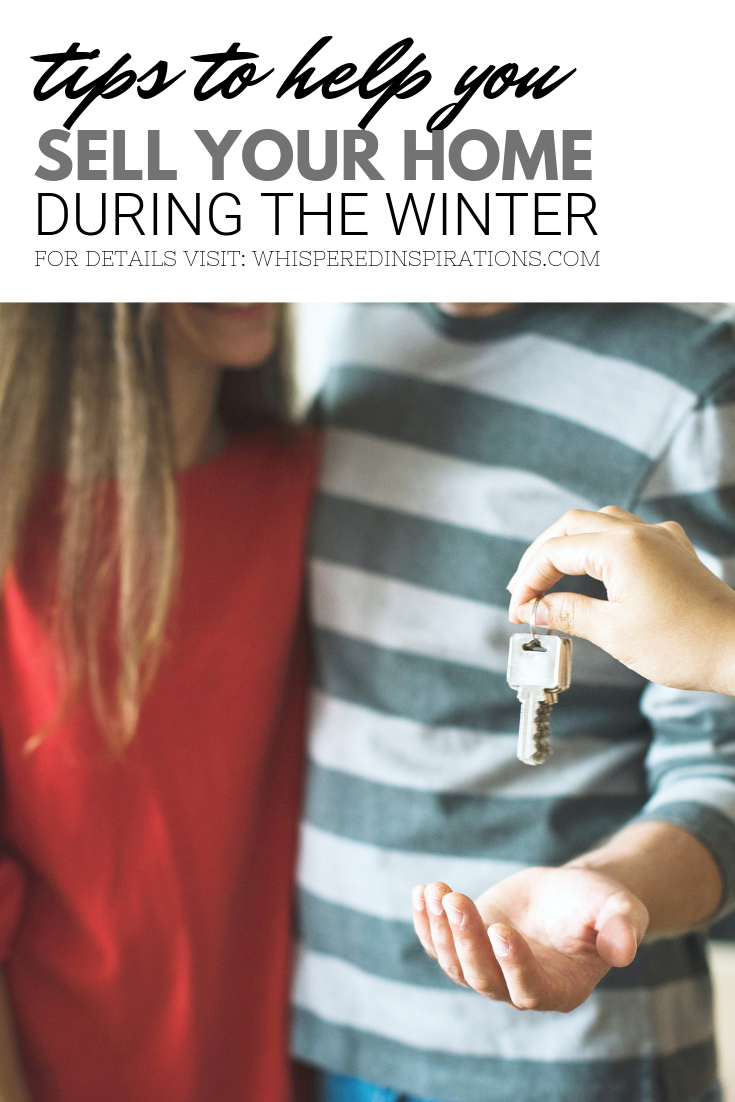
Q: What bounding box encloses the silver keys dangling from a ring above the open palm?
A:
[508,601,572,765]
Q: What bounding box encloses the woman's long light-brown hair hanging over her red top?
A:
[0,303,283,748]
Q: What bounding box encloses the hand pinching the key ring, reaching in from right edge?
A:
[508,506,735,695]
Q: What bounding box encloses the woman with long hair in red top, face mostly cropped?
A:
[0,304,316,1102]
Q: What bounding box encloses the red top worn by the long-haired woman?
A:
[0,430,315,1102]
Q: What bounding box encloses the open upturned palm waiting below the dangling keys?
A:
[413,867,648,1012]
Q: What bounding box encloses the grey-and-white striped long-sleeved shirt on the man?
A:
[294,304,735,1102]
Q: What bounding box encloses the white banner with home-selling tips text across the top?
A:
[0,0,735,301]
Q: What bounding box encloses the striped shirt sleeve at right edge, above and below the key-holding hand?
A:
[634,378,735,917]
